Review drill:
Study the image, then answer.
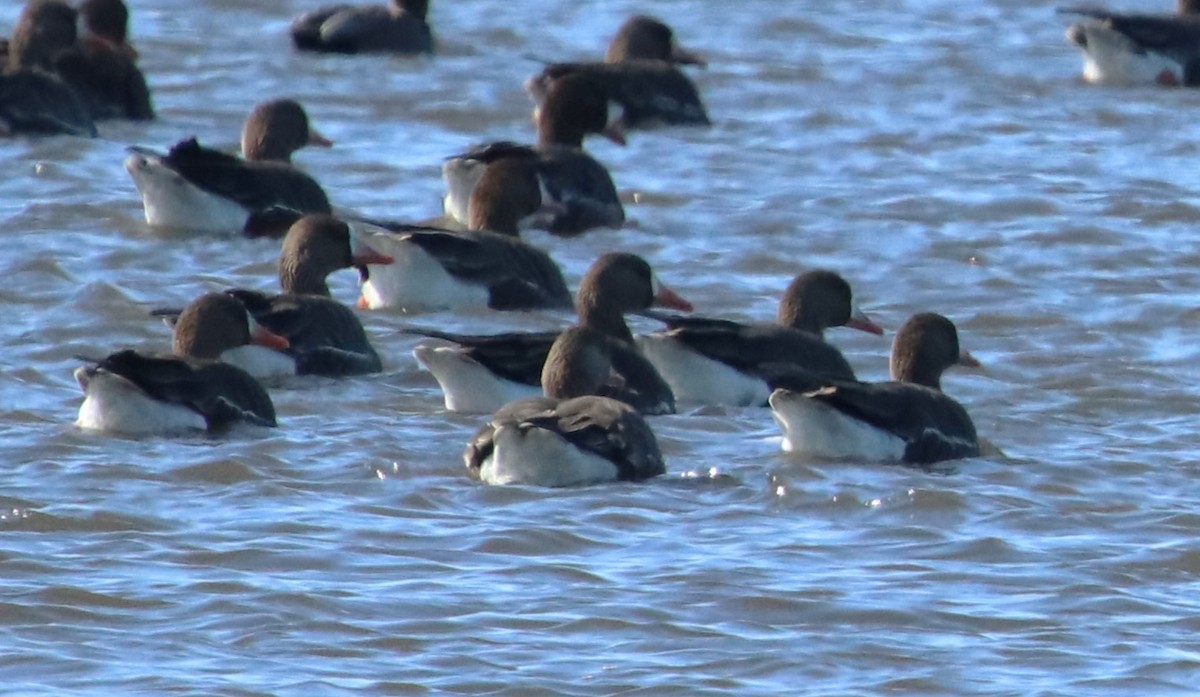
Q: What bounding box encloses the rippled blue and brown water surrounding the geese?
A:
[0,0,1200,696]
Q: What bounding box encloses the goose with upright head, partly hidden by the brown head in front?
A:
[442,76,625,235]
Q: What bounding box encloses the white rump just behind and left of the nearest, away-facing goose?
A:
[413,344,541,414]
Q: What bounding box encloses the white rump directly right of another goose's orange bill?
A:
[352,233,488,311]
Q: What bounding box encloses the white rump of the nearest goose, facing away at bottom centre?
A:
[479,423,617,487]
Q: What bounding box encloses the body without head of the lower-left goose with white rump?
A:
[74,349,275,435]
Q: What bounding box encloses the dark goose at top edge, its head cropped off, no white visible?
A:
[292,0,433,54]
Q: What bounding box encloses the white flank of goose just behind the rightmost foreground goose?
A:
[634,334,770,407]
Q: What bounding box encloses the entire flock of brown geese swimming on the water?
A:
[7,0,1200,486]
